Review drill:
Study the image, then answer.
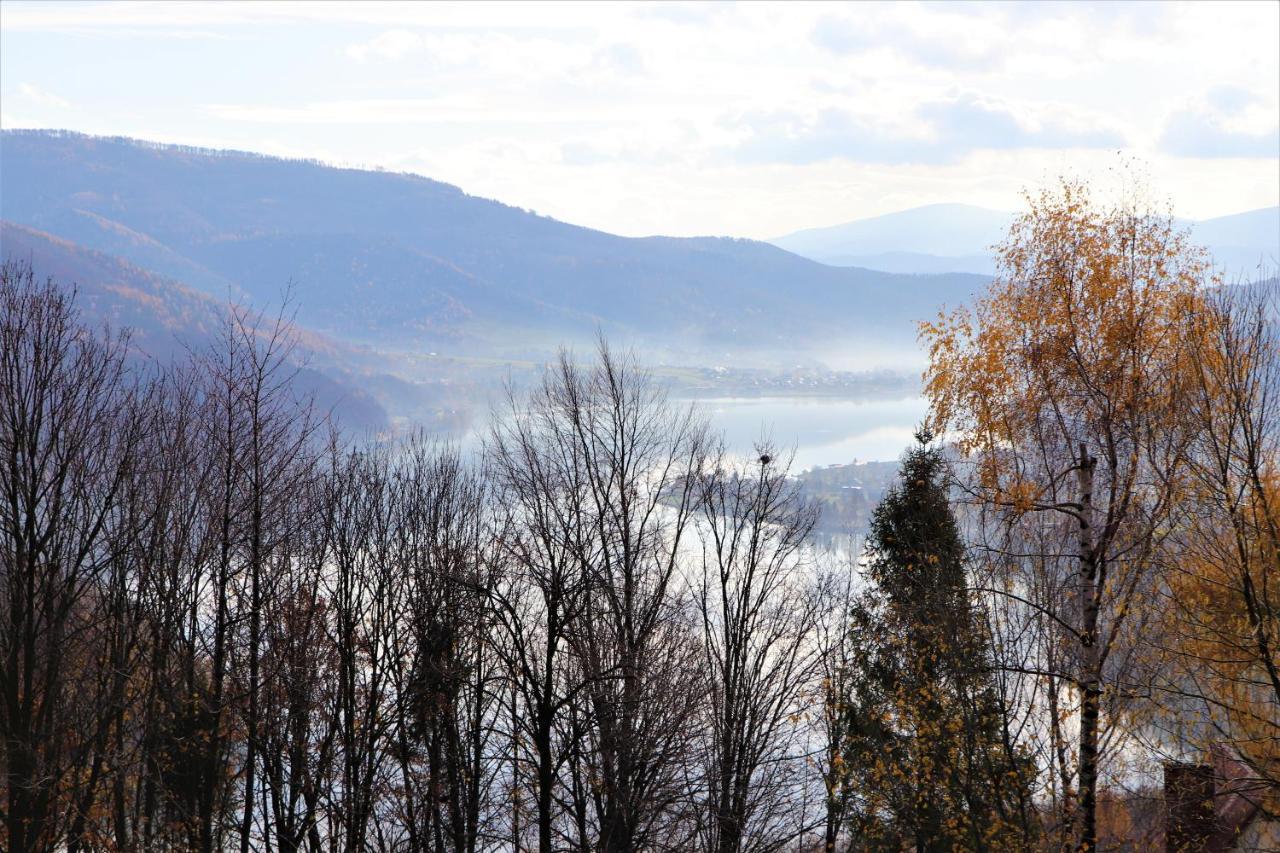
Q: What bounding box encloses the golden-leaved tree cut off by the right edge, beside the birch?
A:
[1157,279,1280,785]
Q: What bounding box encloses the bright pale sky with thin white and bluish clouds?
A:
[0,0,1280,238]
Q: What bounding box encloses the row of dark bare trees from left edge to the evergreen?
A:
[0,265,906,850]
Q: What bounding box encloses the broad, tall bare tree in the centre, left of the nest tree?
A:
[490,345,704,850]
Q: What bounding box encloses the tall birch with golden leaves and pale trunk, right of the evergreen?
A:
[923,175,1207,850]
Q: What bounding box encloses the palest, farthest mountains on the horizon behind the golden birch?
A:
[772,204,1280,275]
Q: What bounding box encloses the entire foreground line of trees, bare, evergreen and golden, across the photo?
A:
[0,183,1280,853]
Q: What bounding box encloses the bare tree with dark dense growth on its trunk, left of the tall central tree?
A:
[393,435,500,852]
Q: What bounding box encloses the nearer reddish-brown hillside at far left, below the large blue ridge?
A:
[0,220,389,430]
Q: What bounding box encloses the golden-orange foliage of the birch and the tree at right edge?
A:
[920,171,1280,835]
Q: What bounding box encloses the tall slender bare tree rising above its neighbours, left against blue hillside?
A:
[188,298,317,853]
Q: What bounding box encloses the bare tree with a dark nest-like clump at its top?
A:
[695,444,820,853]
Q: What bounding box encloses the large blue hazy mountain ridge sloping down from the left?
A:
[0,131,984,357]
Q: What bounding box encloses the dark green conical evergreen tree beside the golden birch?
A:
[845,432,1034,850]
